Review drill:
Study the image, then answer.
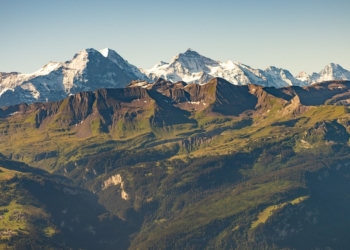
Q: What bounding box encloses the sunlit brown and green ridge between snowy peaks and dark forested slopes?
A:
[0,78,348,174]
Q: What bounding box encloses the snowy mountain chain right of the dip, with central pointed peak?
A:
[143,49,350,88]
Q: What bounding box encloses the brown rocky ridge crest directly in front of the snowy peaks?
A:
[0,78,350,135]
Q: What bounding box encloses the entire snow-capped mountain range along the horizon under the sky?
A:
[0,48,350,106]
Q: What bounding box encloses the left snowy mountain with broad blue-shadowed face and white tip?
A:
[0,49,147,106]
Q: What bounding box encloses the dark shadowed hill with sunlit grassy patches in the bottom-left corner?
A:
[0,156,133,249]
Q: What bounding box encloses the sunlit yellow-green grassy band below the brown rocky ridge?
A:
[0,95,348,176]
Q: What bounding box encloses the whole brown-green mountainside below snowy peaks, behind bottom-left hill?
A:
[0,78,350,249]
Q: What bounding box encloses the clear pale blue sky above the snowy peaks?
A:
[0,0,350,74]
